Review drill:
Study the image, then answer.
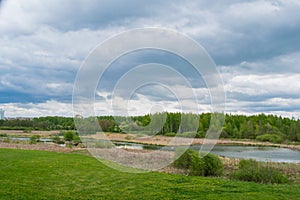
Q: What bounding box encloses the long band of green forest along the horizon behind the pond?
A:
[0,112,300,143]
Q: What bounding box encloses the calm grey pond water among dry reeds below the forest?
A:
[115,142,300,163]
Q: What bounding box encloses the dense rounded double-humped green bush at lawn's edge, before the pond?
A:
[174,149,223,176]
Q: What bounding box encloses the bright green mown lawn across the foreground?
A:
[0,149,300,200]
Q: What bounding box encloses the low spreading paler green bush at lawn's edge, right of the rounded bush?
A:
[231,159,289,183]
